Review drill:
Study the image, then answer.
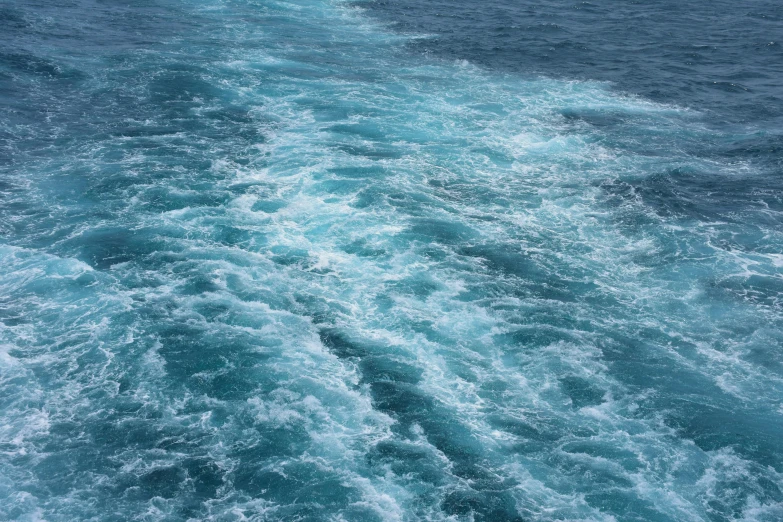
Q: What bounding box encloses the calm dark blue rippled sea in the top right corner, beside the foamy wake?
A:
[360,0,783,123]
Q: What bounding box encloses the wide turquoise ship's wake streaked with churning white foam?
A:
[0,2,783,520]
